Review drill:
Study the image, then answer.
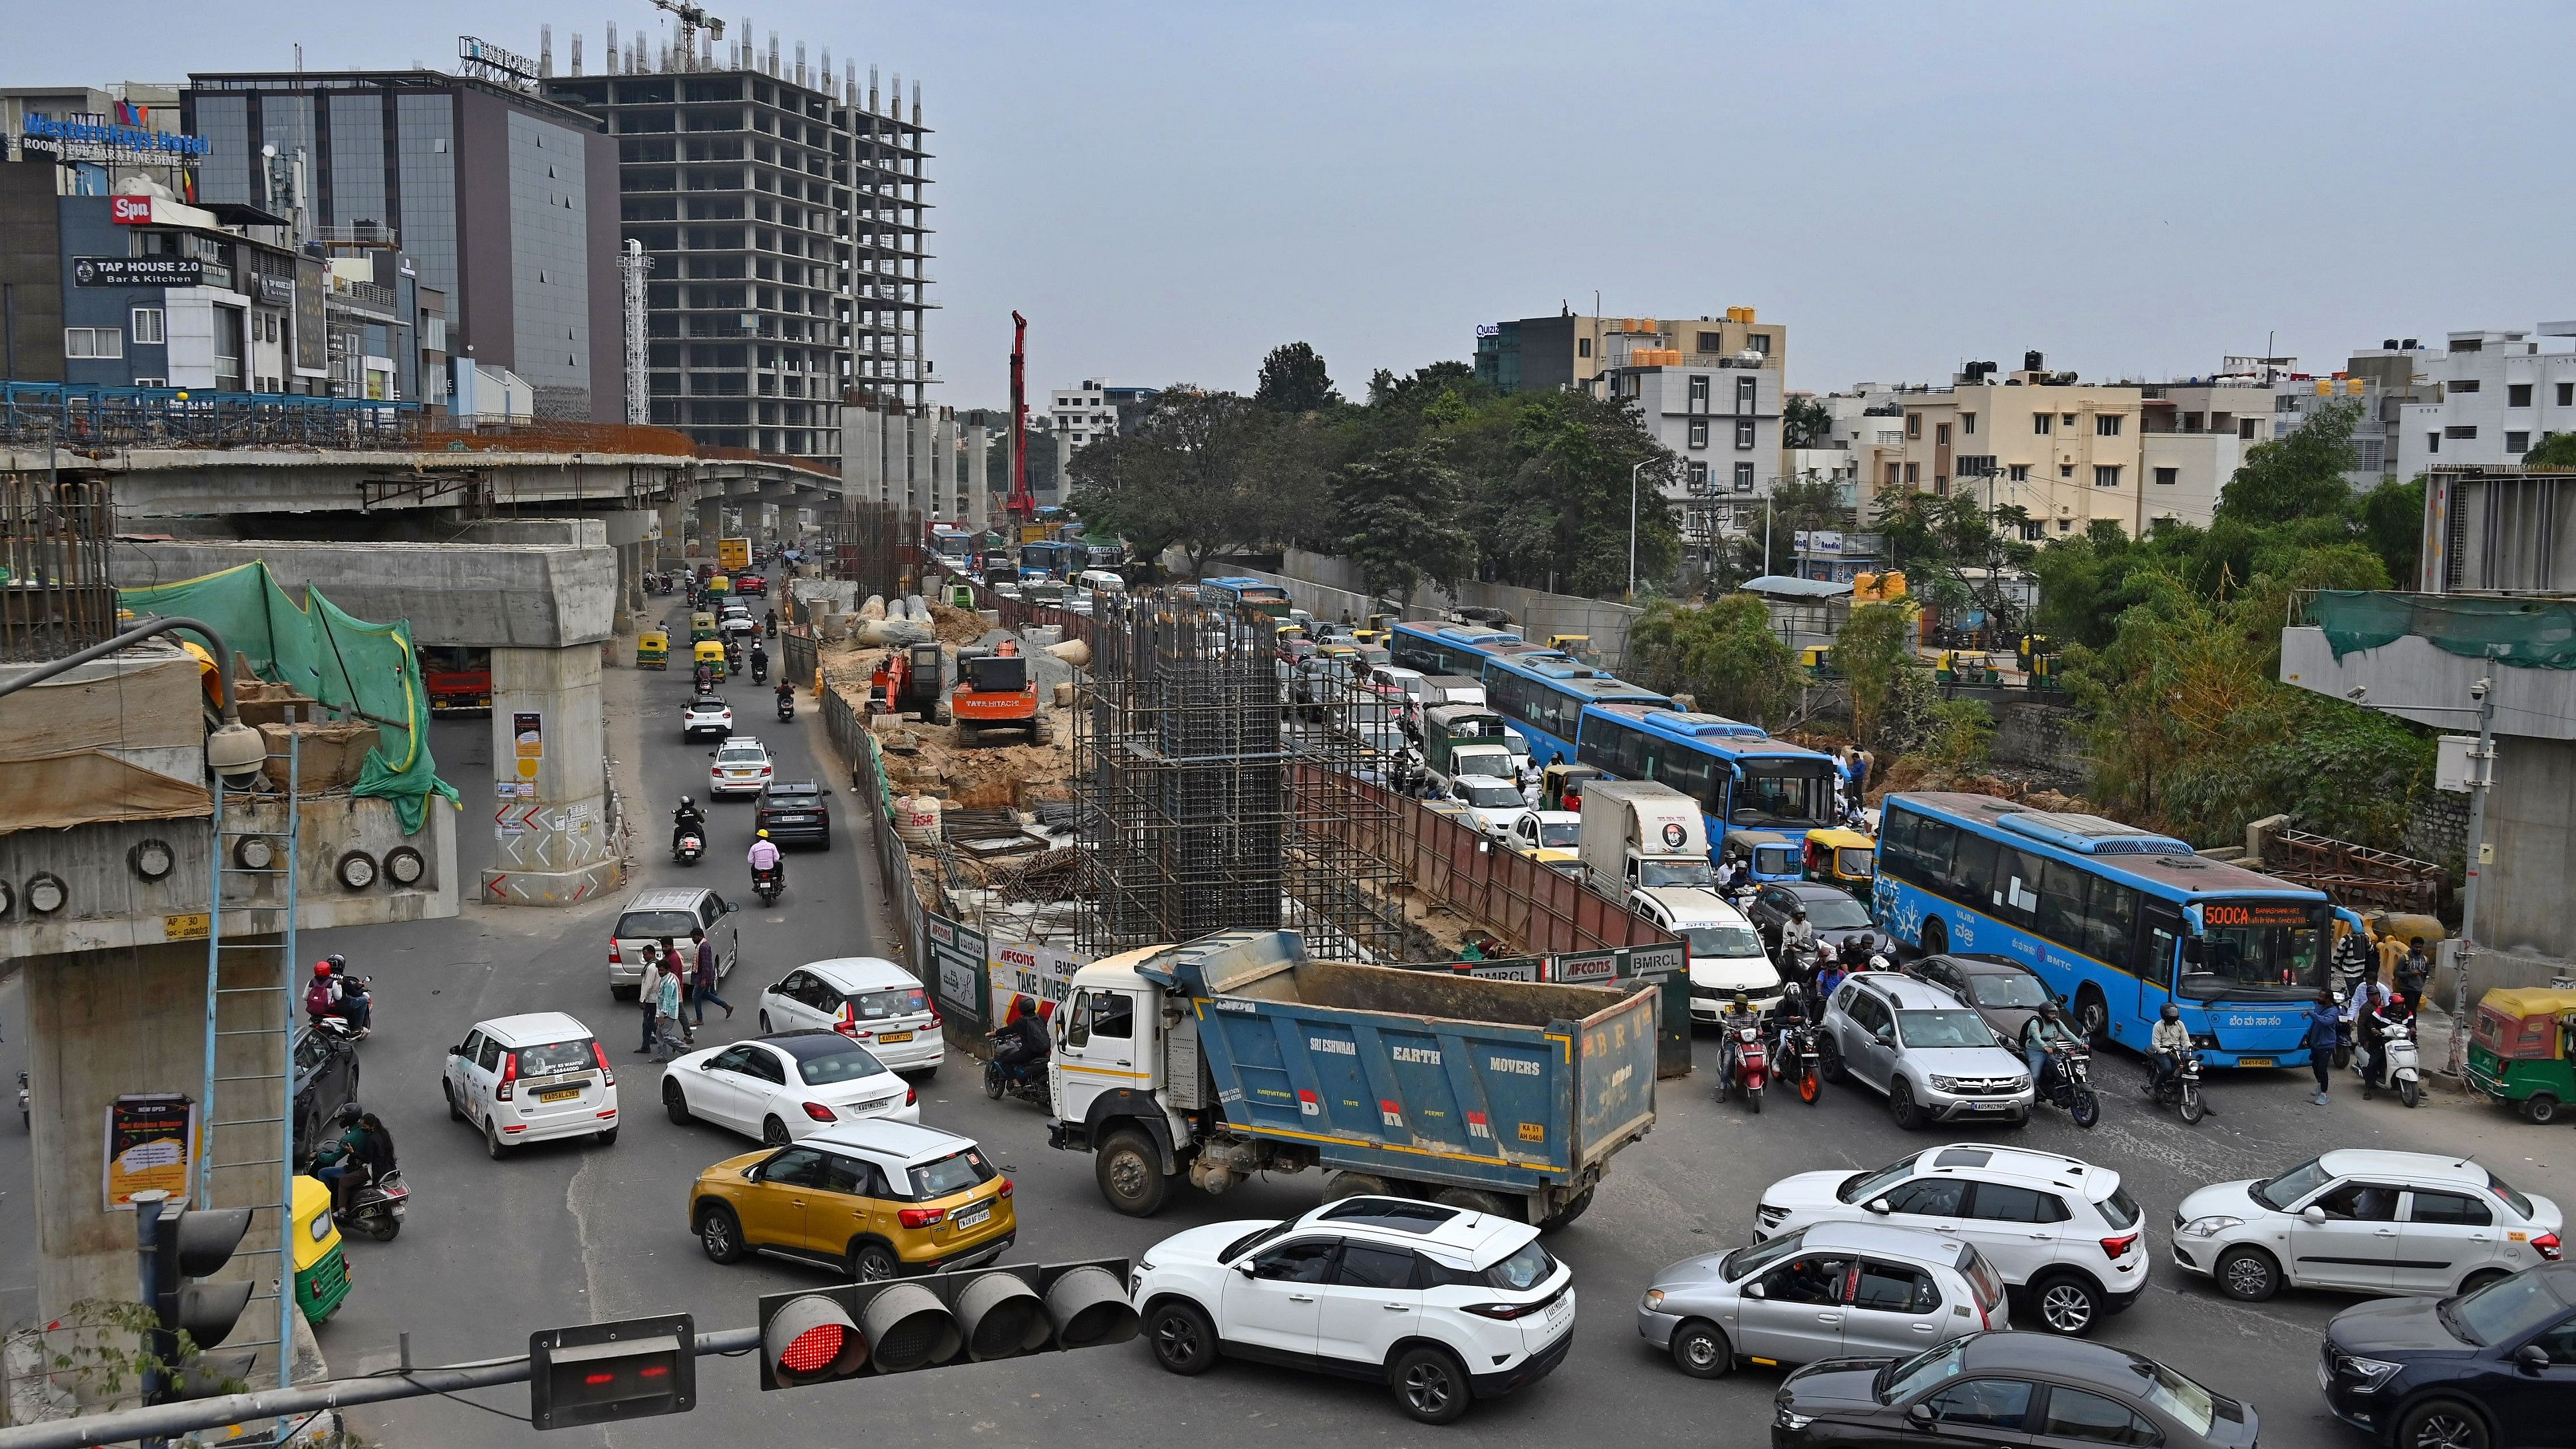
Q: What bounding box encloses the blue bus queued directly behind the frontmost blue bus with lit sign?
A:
[1574,703,1836,880]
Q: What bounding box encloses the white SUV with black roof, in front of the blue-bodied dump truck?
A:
[1128,1197,1574,1423]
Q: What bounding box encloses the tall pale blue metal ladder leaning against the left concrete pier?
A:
[193,708,304,1387]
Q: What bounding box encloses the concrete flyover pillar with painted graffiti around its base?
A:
[482,644,626,906]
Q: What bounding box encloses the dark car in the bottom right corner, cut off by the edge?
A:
[2319,1263,2576,1449]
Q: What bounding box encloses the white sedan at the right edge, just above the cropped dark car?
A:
[2174,1148,2566,1302]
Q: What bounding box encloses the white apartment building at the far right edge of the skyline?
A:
[2355,322,2576,479]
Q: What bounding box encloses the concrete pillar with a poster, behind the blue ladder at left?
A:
[21,942,287,1338]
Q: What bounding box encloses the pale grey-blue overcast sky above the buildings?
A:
[25,0,2576,407]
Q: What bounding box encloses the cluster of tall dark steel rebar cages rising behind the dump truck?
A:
[1074,594,1404,960]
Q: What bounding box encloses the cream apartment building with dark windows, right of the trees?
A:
[1876,352,2148,541]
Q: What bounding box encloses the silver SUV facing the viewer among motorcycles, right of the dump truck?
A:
[1816,970,2033,1132]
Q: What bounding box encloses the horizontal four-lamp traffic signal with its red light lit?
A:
[760,1259,1139,1390]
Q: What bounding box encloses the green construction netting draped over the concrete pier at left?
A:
[118,561,458,834]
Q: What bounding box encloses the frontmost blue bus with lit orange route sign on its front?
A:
[1876,793,2334,1065]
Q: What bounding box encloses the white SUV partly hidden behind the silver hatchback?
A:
[1755,1142,2148,1336]
